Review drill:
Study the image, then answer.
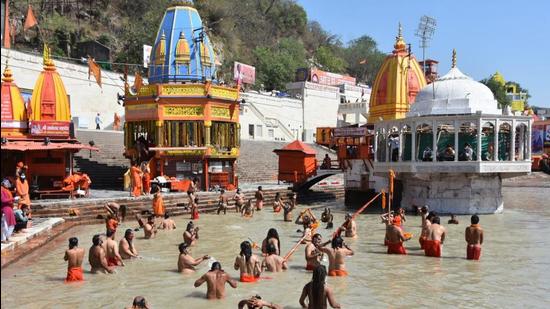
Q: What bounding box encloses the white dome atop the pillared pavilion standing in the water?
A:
[407,67,502,117]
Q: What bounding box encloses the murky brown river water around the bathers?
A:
[1,187,550,309]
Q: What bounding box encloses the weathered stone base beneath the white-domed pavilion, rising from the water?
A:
[399,173,504,214]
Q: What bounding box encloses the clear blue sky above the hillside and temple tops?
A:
[297,0,550,107]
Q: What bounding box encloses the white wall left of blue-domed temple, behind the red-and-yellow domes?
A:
[1,48,140,129]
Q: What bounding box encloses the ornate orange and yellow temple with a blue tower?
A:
[124,5,240,190]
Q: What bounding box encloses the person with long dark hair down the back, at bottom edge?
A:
[300,265,341,309]
